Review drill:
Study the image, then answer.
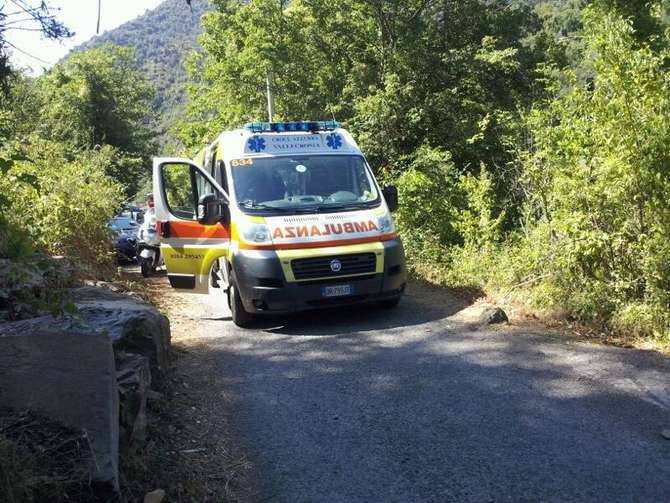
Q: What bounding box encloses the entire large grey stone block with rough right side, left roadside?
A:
[0,287,170,489]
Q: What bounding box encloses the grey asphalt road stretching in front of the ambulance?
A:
[164,284,670,503]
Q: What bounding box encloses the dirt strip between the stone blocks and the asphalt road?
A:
[121,268,258,503]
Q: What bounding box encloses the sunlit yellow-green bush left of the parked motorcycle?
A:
[0,141,123,274]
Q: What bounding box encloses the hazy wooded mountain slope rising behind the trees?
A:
[74,0,208,144]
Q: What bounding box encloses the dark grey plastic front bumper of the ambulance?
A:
[233,239,407,314]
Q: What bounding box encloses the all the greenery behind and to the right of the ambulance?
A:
[176,0,670,347]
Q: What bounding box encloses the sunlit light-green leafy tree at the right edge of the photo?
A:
[525,4,670,336]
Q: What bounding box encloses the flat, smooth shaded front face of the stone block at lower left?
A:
[0,316,119,488]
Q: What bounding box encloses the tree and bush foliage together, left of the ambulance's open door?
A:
[0,46,153,273]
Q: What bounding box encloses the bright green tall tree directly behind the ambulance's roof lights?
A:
[181,0,378,146]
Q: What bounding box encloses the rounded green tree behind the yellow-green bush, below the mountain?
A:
[38,46,154,193]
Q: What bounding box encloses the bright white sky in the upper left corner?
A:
[0,0,163,75]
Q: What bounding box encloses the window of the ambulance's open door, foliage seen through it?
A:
[161,163,217,220]
